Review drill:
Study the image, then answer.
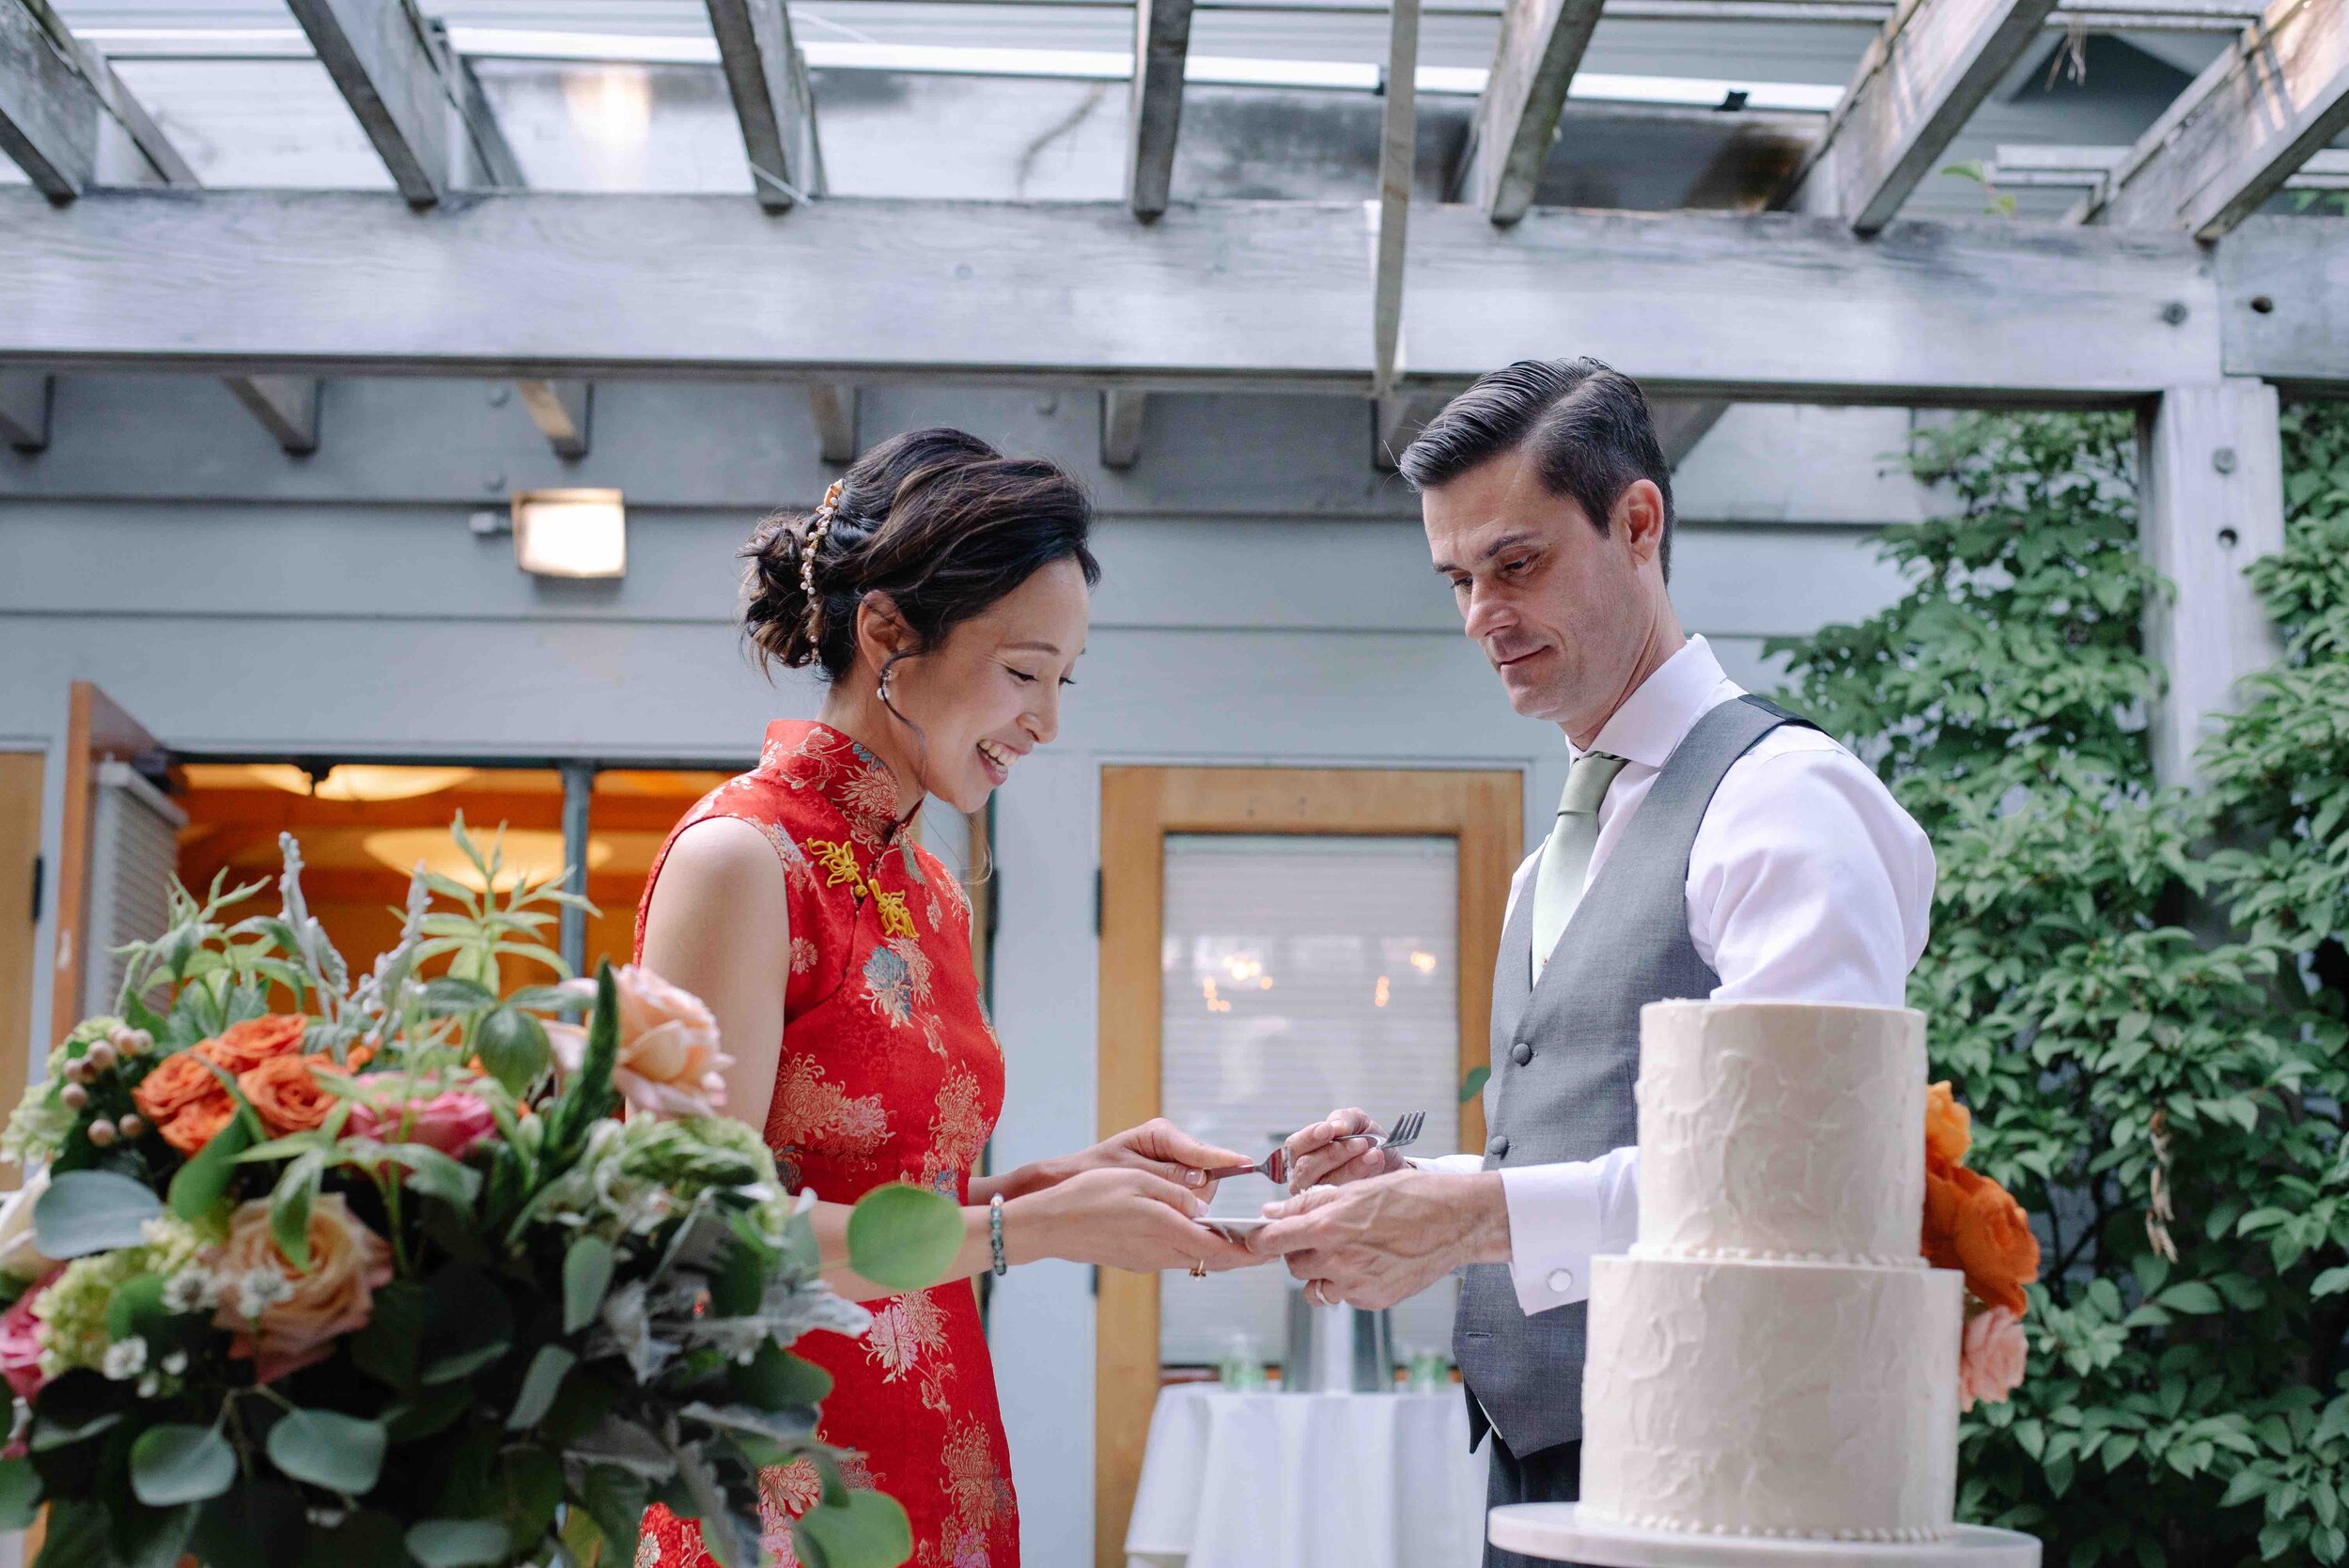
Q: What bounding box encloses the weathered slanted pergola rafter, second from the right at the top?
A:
[1781,0,2056,235]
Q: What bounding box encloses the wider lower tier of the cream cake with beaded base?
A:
[1583,1258,1964,1543]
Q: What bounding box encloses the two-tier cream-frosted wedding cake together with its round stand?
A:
[1494,1002,2039,1568]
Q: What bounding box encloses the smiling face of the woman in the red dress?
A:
[872,561,1093,812]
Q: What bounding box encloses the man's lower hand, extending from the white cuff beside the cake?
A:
[1248,1172,1508,1308]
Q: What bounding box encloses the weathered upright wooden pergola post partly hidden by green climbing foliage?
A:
[2138,376,2283,784]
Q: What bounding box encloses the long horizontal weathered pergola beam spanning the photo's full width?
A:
[0,190,2311,406]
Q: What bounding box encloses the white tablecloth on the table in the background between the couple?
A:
[1126,1383,1485,1568]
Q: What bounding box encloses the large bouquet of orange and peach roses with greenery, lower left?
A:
[0,819,938,1568]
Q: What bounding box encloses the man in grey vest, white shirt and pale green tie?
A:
[1252,359,1934,1568]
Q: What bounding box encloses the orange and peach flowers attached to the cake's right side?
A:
[1924,1082,2039,1411]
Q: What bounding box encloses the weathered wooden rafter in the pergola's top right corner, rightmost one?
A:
[2070,0,2349,240]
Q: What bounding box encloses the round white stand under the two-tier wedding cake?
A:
[1487,1502,2039,1568]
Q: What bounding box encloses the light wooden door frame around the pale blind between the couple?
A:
[1093,768,1525,1568]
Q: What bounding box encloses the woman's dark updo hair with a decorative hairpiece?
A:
[742,429,1102,681]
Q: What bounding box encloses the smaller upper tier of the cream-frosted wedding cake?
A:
[1635,1002,1926,1267]
